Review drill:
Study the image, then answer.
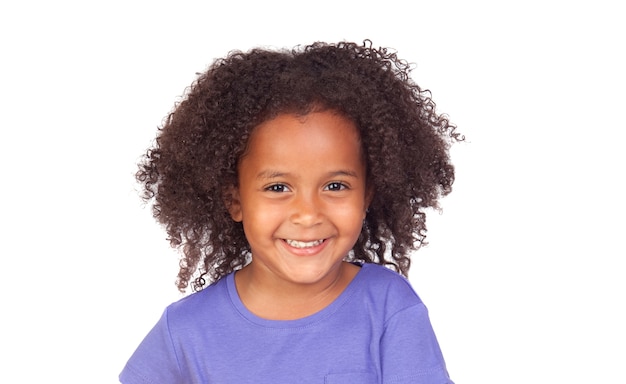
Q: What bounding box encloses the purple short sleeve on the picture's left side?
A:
[119,311,183,384]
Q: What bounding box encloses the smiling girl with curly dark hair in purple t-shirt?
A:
[120,41,462,384]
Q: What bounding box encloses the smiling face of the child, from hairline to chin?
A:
[230,111,368,284]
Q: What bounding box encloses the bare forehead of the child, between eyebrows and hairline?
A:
[240,111,363,172]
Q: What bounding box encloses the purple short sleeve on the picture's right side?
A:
[380,303,453,384]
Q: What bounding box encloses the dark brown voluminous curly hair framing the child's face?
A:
[136,40,463,292]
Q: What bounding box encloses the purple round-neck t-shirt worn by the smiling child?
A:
[120,264,452,384]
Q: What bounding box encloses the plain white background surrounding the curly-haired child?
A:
[0,0,626,384]
